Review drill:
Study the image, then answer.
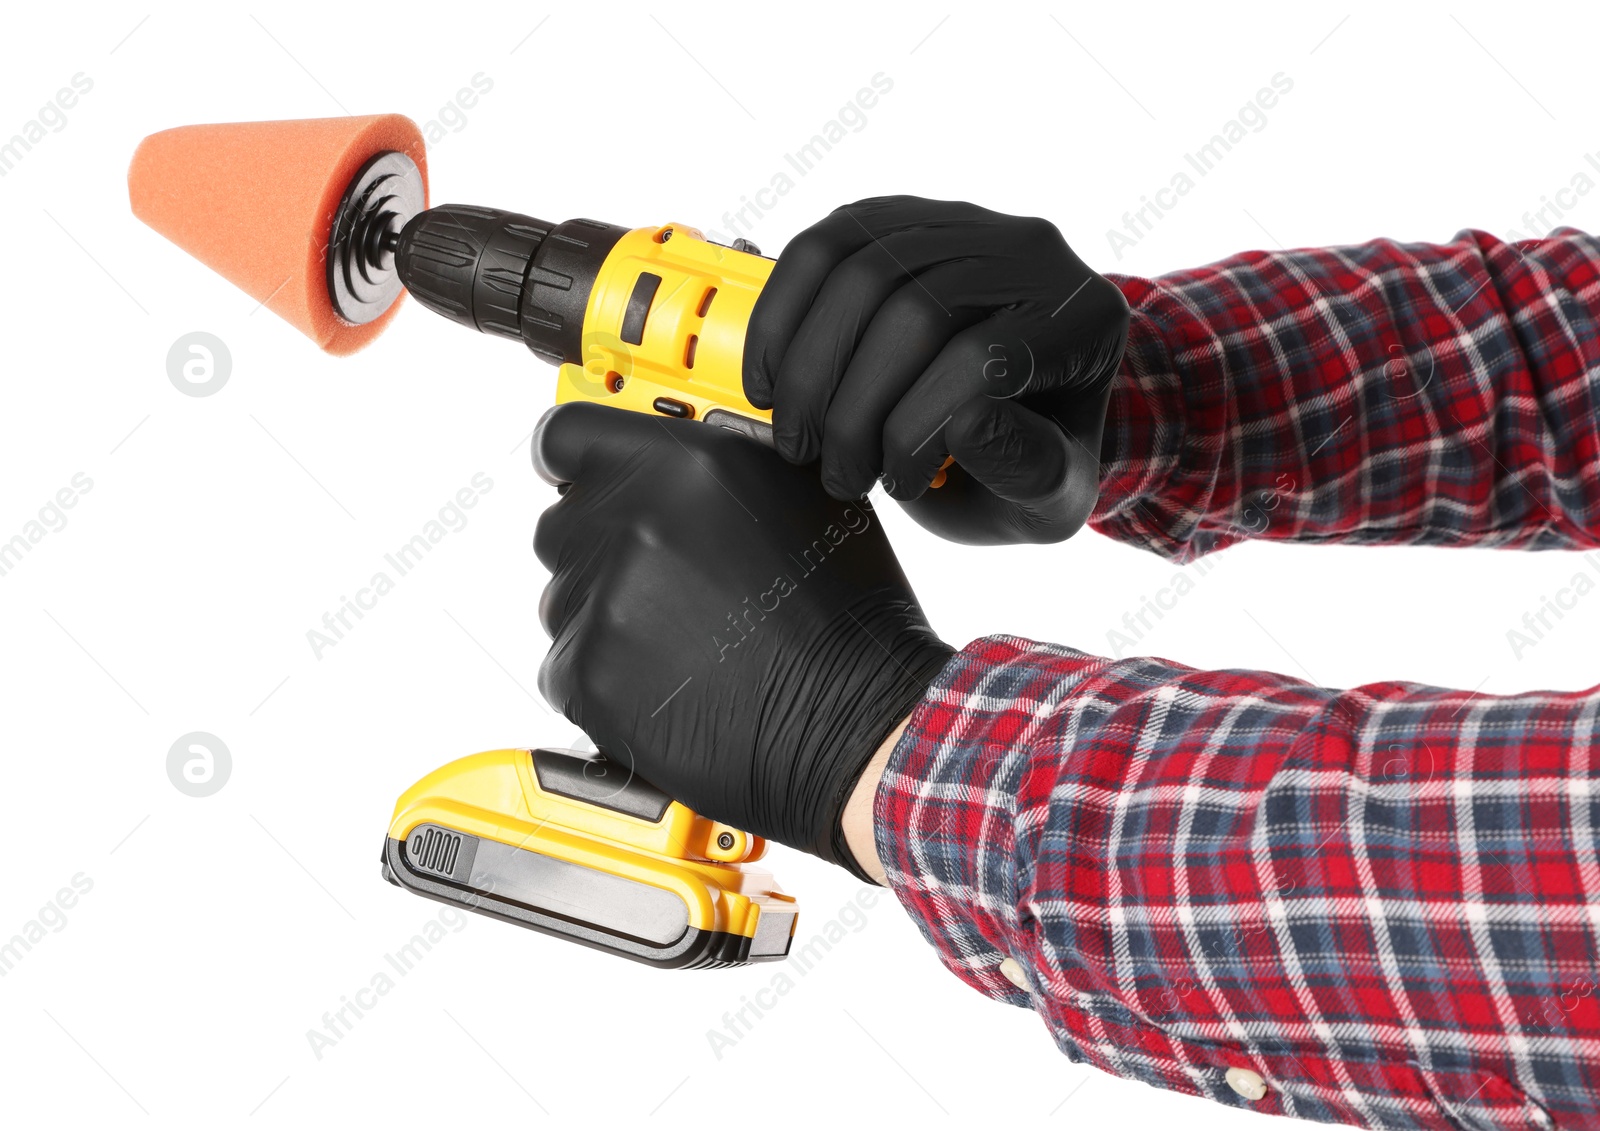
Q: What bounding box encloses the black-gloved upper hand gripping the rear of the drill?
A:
[744,197,1128,544]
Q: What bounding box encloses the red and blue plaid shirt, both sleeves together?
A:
[875,232,1600,1131]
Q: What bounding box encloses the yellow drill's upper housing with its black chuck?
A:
[394,205,773,443]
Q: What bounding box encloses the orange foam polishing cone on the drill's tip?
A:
[128,114,427,354]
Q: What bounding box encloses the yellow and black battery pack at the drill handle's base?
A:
[382,749,798,969]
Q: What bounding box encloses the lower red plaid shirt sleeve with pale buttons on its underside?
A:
[875,637,1600,1131]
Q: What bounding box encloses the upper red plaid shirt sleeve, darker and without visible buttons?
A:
[1091,229,1600,562]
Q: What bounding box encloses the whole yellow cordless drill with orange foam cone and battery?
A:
[128,115,832,969]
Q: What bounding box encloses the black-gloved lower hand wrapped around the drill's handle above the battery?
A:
[533,403,952,878]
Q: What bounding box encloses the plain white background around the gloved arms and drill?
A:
[0,3,1600,1128]
